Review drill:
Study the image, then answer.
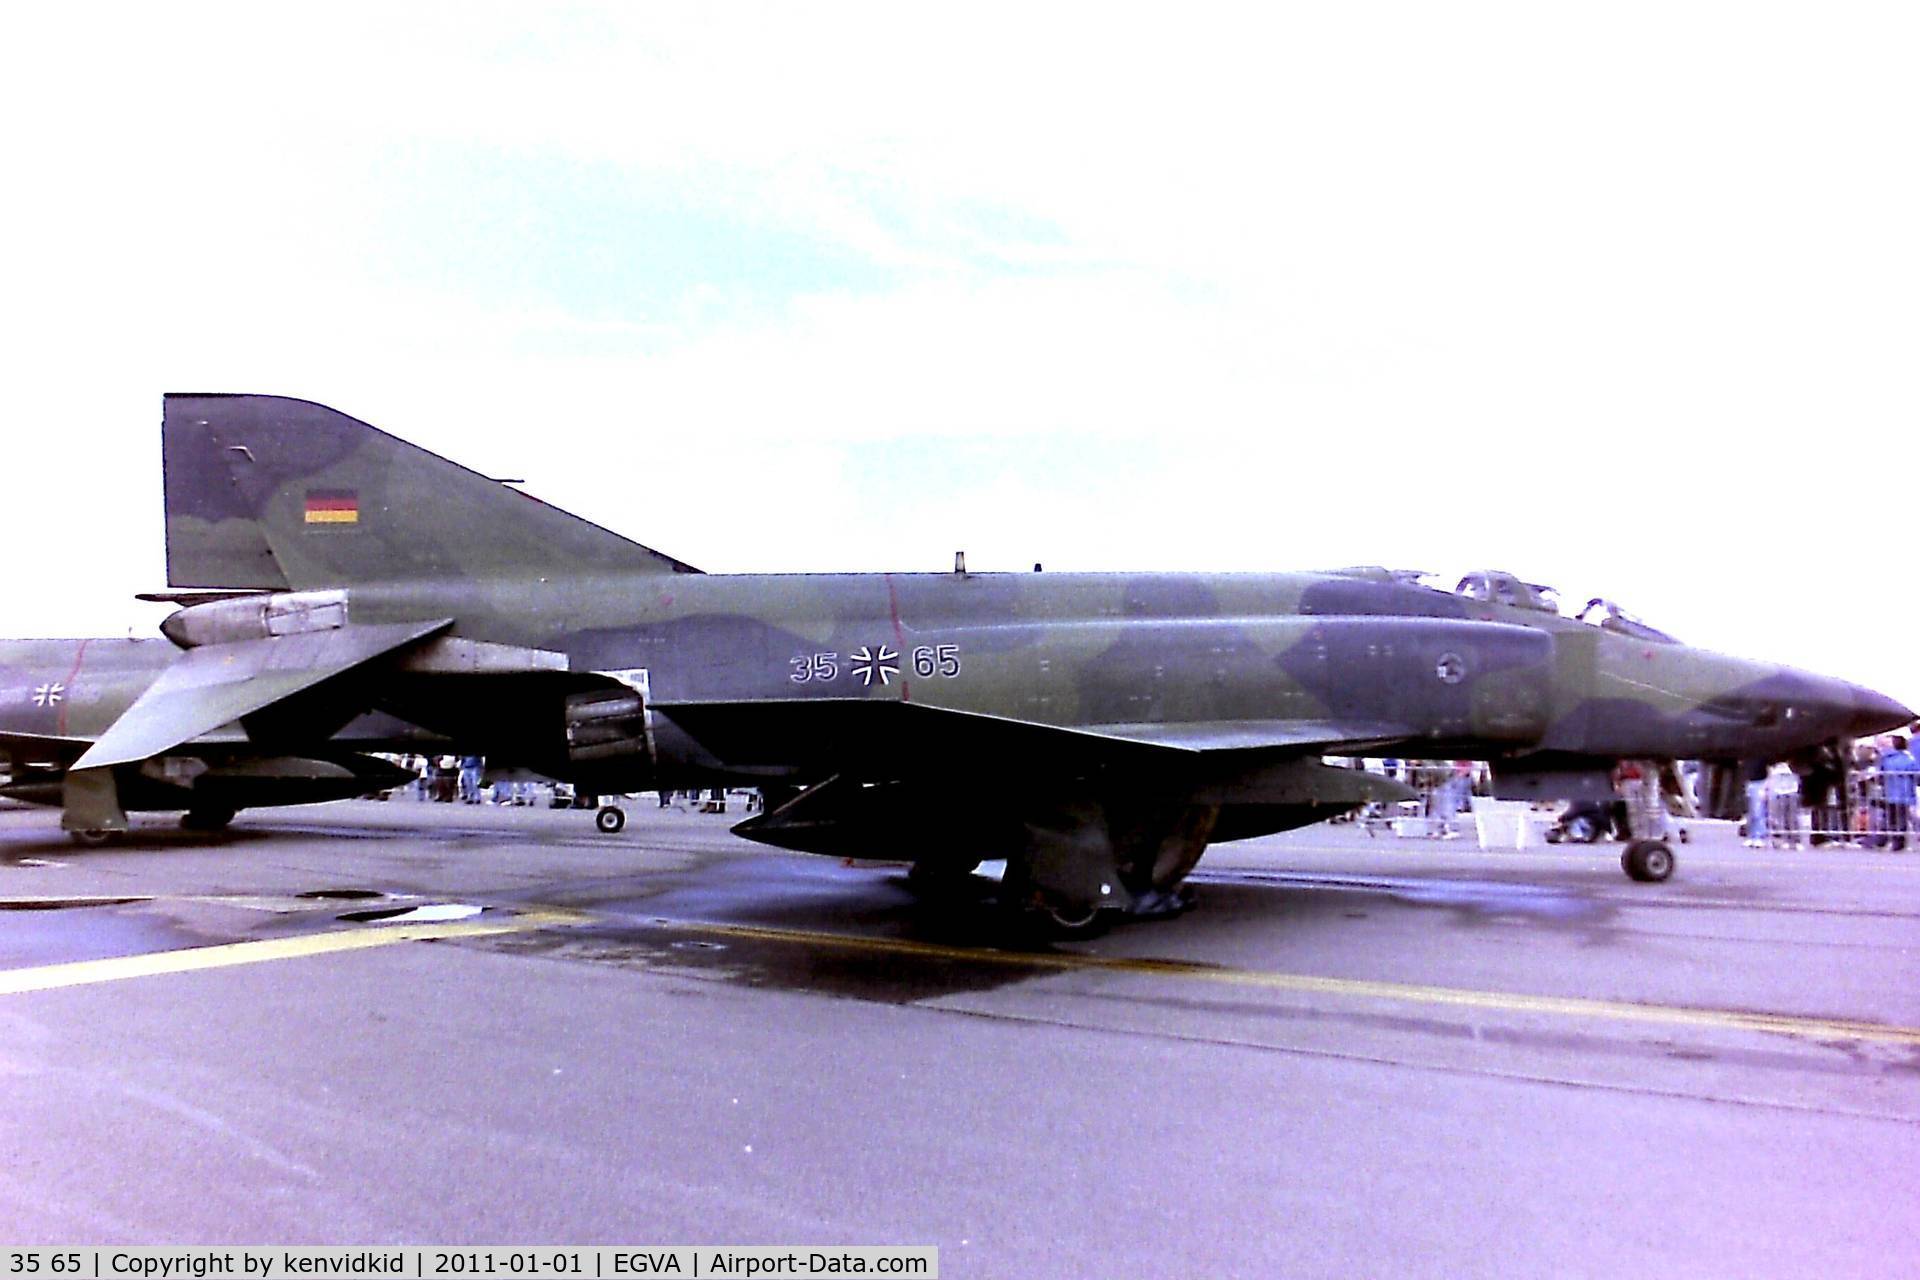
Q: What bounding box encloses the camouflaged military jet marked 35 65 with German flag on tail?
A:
[41,393,1912,929]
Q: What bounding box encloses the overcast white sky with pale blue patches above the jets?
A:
[0,0,1920,702]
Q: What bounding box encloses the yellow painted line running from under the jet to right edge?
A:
[670,921,1920,1046]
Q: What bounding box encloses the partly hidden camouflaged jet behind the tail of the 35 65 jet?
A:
[0,637,442,837]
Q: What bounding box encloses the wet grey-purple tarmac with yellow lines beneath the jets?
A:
[0,796,1920,1276]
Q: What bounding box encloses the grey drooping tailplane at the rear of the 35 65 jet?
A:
[73,618,451,771]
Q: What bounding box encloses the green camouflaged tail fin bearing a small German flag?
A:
[163,393,699,591]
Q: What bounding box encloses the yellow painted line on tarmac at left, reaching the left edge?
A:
[0,910,588,996]
